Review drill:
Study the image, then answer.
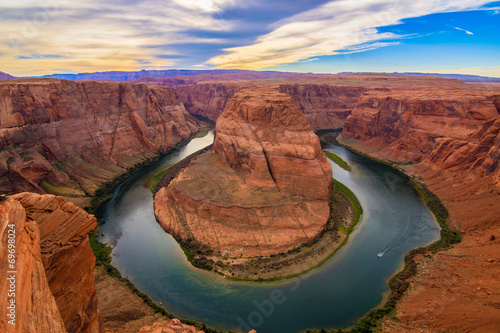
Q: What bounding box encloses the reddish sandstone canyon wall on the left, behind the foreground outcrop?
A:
[0,80,198,205]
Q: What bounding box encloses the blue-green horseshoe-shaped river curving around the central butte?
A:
[97,133,439,333]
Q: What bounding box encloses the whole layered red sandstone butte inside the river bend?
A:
[154,87,332,257]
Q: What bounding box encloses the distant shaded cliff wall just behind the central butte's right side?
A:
[280,84,367,130]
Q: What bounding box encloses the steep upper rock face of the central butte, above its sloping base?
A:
[214,89,332,200]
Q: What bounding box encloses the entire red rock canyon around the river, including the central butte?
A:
[0,73,500,332]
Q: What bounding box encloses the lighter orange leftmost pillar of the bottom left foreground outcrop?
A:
[0,199,66,333]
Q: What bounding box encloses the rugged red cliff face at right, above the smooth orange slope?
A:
[342,89,498,162]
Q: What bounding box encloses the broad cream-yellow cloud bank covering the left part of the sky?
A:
[0,0,233,75]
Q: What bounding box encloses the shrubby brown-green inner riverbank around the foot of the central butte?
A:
[148,144,362,281]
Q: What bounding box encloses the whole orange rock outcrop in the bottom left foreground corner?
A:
[0,193,102,332]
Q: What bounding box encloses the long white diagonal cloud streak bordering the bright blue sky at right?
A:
[208,0,491,70]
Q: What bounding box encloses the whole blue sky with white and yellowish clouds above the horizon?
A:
[0,0,500,77]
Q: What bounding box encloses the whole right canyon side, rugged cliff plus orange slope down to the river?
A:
[340,81,500,332]
